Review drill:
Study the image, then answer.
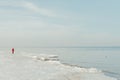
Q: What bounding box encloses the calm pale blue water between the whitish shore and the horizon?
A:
[1,47,120,80]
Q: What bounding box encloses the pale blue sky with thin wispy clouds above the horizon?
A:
[0,0,120,47]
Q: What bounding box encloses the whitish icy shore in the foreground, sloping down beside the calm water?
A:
[0,52,117,80]
